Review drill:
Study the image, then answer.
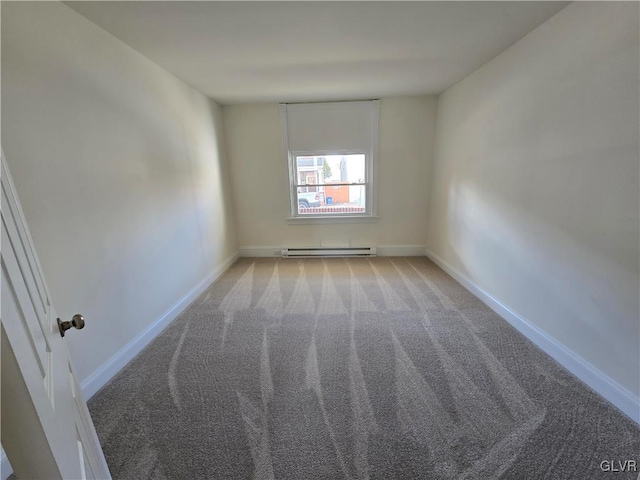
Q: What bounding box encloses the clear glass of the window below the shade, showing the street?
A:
[296,154,367,215]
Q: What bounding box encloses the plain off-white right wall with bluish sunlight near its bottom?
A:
[427,2,640,398]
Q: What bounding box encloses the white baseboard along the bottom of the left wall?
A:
[82,252,238,400]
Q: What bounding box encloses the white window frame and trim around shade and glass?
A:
[280,100,380,223]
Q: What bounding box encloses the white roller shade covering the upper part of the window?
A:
[280,100,379,153]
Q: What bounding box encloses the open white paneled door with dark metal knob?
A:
[0,155,111,480]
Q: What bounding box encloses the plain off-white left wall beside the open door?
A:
[2,2,236,386]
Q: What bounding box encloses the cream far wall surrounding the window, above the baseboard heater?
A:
[223,96,436,252]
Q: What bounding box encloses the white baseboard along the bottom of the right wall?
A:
[425,249,640,424]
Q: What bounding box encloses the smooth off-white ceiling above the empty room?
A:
[67,1,569,104]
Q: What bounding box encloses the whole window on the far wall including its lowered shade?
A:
[280,101,378,221]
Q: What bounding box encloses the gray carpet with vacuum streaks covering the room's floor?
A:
[89,257,640,480]
